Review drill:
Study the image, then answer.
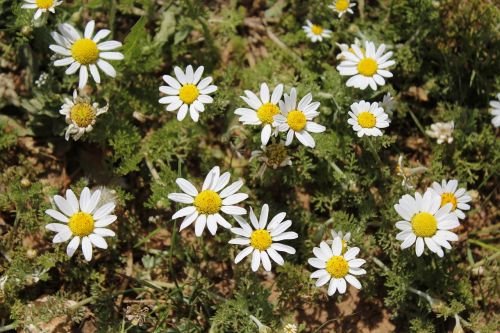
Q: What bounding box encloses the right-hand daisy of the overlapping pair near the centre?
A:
[274,88,326,148]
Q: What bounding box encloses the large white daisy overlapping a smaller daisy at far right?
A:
[394,189,460,257]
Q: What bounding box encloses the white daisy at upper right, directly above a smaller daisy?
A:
[337,41,396,90]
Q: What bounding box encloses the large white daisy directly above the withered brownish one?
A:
[49,20,123,89]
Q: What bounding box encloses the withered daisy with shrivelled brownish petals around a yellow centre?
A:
[59,90,108,141]
